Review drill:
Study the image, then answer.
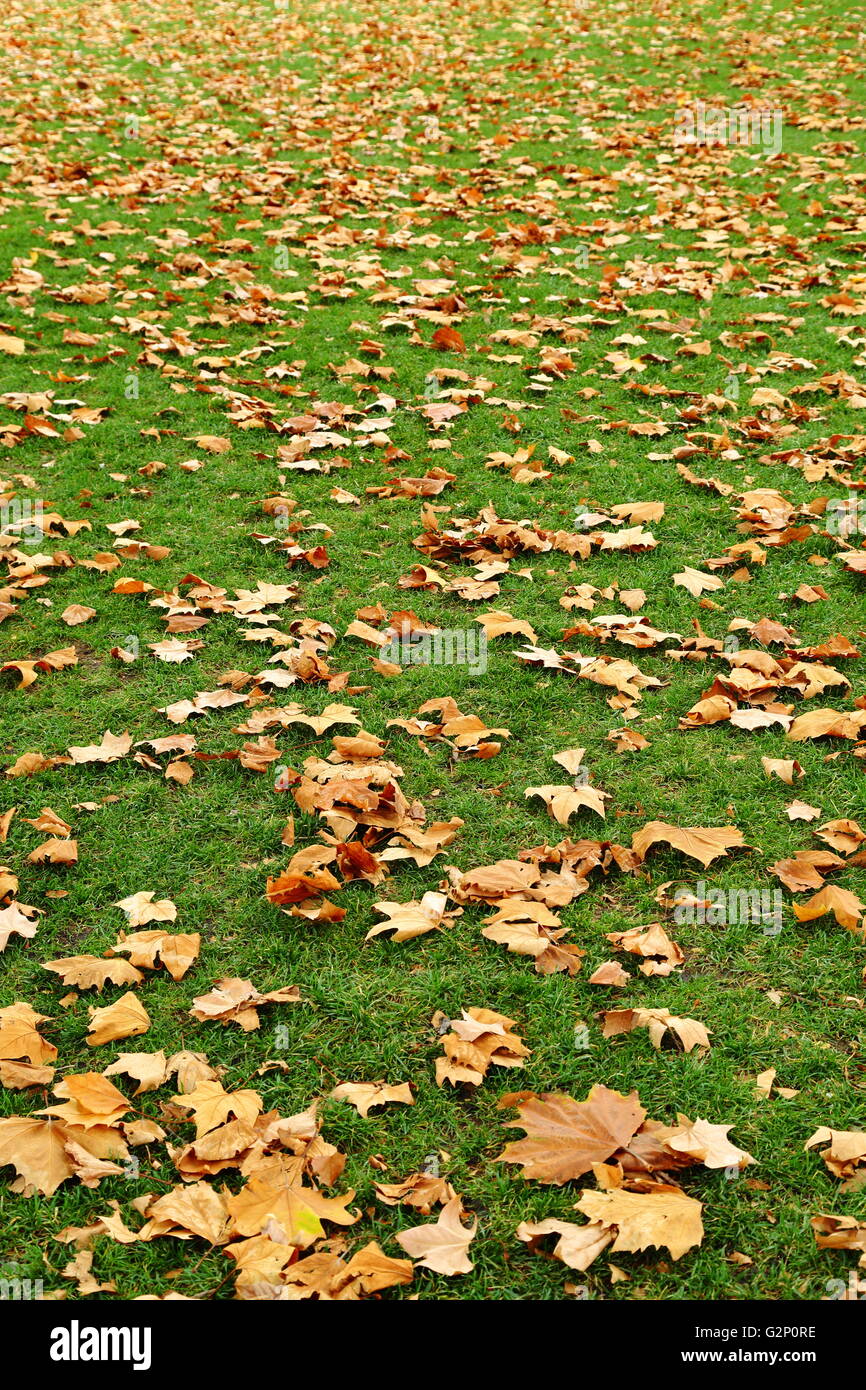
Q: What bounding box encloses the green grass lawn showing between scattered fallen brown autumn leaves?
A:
[0,0,866,1300]
